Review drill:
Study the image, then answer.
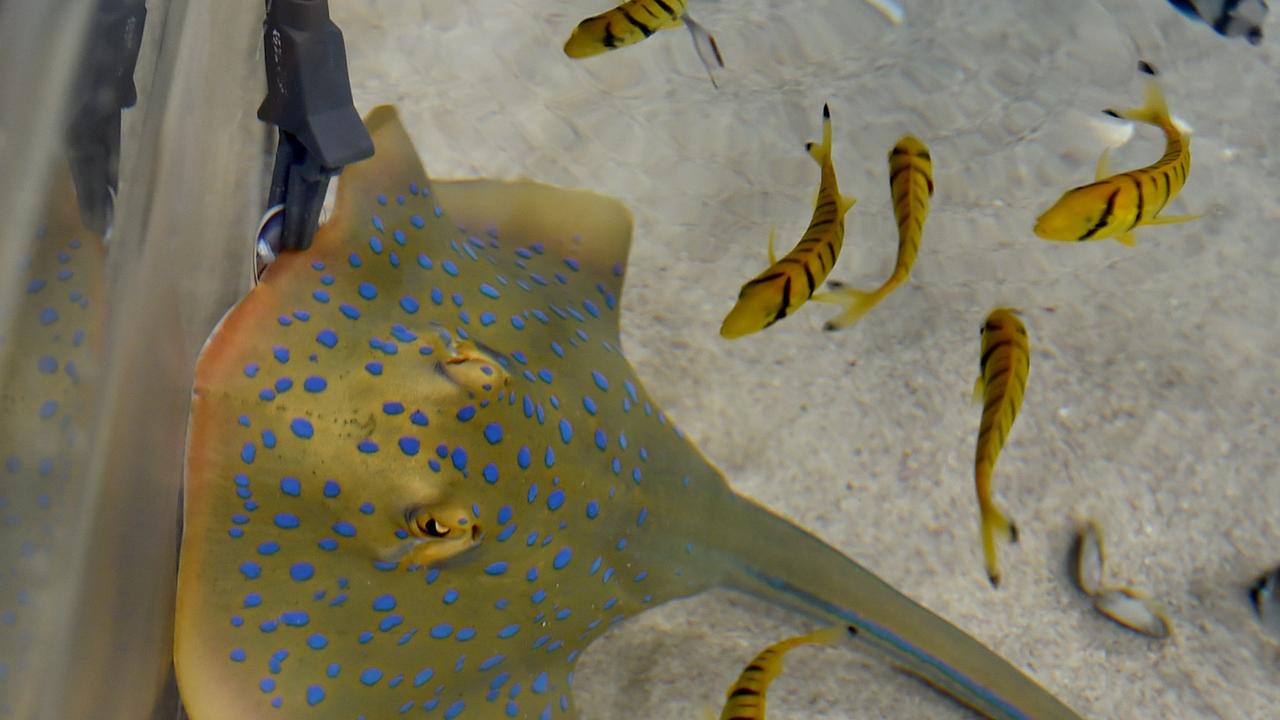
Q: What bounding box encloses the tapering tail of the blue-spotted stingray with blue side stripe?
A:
[714,497,1082,720]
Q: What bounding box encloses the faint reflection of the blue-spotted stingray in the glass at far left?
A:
[0,169,106,719]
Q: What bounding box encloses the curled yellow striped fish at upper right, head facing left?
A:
[1036,63,1199,246]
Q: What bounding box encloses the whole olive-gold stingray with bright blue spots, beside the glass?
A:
[175,106,1079,720]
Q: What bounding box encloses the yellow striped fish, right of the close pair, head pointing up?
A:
[813,135,933,331]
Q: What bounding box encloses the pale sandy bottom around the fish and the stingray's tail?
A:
[333,0,1280,719]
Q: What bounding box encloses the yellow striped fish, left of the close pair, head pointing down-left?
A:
[721,105,858,340]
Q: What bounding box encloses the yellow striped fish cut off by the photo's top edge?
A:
[564,0,724,87]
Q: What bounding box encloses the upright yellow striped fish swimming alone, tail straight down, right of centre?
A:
[973,307,1032,587]
